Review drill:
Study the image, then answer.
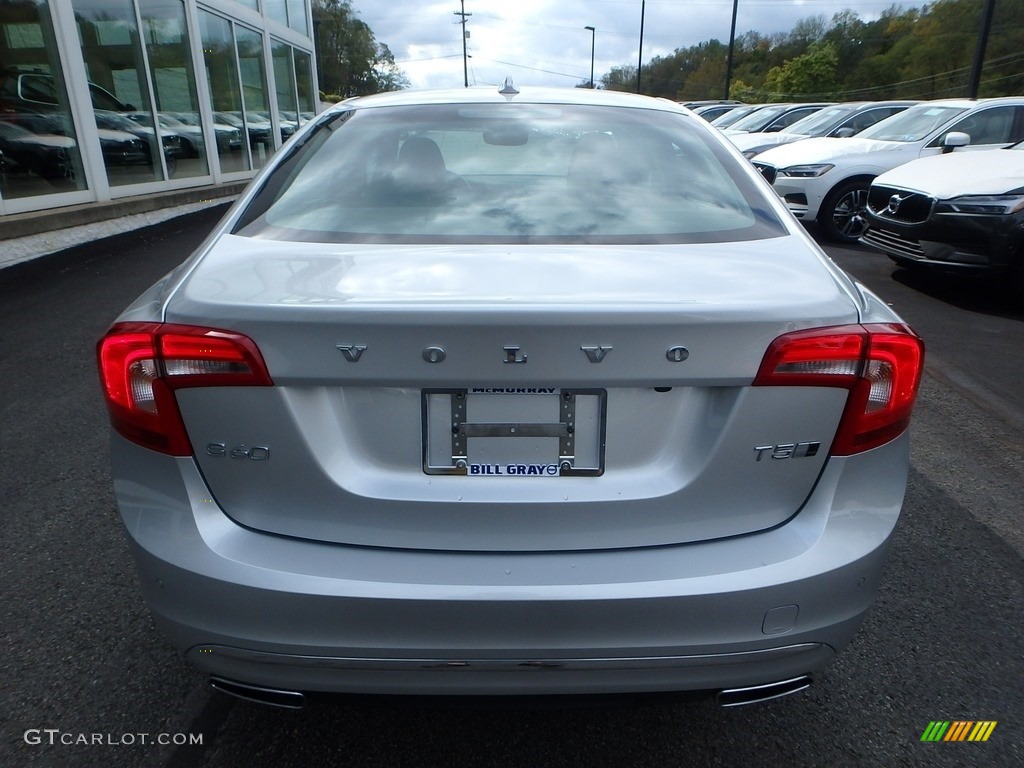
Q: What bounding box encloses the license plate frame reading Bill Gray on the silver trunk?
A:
[422,387,607,477]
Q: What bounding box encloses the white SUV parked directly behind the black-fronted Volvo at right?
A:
[754,96,1024,243]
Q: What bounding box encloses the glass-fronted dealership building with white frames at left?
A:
[0,0,318,222]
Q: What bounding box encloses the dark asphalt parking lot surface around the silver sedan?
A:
[0,207,1024,768]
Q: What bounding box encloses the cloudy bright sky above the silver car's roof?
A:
[352,0,924,88]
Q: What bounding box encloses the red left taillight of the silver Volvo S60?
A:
[97,323,273,456]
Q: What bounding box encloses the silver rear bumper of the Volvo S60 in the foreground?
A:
[114,434,908,694]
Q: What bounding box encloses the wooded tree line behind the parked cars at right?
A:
[600,0,1024,101]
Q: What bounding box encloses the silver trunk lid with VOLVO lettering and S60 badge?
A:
[166,237,858,551]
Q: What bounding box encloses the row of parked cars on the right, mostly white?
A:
[712,97,1024,302]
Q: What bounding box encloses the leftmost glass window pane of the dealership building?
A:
[0,0,87,200]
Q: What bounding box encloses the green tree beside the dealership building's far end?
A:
[312,0,409,97]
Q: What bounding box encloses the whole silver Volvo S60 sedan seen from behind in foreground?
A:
[98,82,923,707]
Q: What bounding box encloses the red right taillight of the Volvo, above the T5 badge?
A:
[754,324,925,456]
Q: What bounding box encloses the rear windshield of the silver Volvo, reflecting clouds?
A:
[234,103,784,243]
